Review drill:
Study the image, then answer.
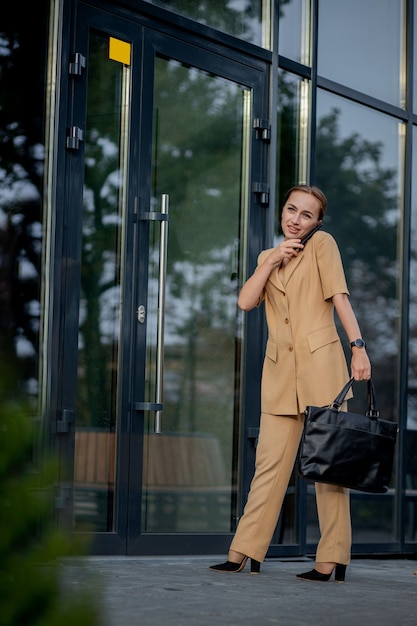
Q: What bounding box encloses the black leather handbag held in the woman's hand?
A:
[298,378,398,493]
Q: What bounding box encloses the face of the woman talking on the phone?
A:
[281,191,321,239]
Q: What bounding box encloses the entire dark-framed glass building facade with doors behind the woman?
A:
[0,0,417,555]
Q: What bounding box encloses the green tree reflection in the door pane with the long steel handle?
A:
[153,60,243,438]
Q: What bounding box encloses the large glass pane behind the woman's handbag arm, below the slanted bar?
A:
[310,90,404,543]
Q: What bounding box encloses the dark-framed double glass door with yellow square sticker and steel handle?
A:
[63,7,267,554]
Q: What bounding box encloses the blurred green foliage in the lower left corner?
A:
[0,376,99,626]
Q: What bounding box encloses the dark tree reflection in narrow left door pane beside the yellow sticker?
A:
[77,35,121,427]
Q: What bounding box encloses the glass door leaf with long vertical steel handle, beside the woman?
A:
[128,32,264,554]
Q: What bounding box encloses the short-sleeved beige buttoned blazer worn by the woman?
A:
[258,231,352,415]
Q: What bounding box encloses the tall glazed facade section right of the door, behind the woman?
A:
[276,0,408,550]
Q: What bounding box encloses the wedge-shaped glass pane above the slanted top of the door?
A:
[141,0,270,48]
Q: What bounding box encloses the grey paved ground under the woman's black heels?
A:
[63,555,417,626]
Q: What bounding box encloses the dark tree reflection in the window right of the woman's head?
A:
[316,109,399,417]
